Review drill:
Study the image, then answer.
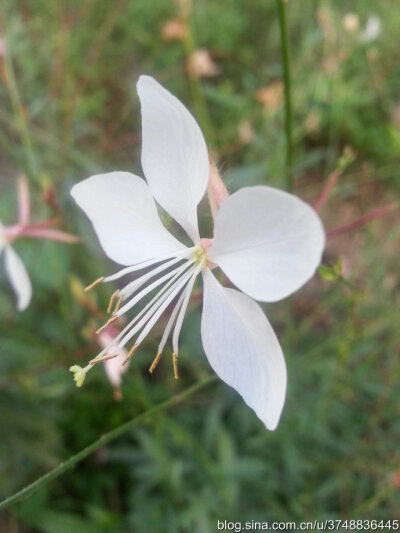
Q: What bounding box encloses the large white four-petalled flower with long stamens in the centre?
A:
[72,76,325,429]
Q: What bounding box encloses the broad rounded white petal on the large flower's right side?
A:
[207,186,325,302]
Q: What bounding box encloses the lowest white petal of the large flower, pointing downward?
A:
[201,269,286,430]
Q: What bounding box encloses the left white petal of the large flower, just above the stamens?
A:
[71,172,185,265]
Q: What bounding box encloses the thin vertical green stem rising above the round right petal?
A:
[276,0,293,192]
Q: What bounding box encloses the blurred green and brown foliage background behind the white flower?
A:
[0,0,400,533]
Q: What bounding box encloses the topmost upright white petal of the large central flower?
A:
[137,76,209,242]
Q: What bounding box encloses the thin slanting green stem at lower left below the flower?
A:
[0,376,217,510]
